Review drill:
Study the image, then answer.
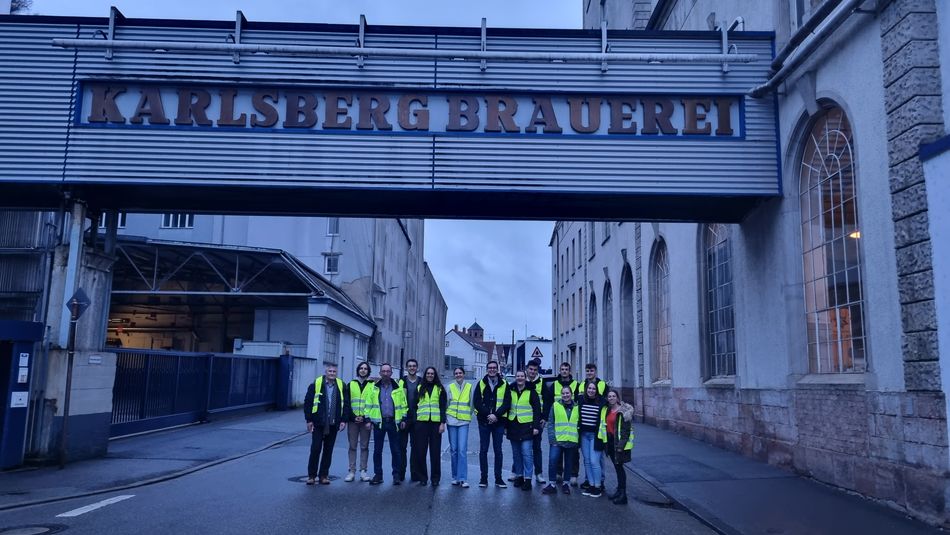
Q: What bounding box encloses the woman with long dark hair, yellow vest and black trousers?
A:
[409,366,448,487]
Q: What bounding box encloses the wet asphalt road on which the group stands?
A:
[0,435,713,535]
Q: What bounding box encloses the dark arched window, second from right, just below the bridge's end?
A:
[703,224,736,379]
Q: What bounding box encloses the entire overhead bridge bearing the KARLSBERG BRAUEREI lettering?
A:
[0,17,782,222]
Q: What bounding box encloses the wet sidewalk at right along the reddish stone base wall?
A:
[628,424,946,535]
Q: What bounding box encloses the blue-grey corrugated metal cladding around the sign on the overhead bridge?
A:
[0,21,780,216]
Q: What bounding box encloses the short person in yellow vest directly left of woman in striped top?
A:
[541,385,580,494]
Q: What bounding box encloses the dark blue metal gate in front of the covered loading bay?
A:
[110,349,280,437]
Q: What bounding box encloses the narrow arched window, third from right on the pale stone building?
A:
[650,239,673,381]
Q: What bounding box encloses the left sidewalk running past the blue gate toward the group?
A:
[0,410,306,511]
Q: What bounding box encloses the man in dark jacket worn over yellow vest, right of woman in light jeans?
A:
[472,360,511,489]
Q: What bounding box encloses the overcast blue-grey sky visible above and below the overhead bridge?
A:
[31,0,583,341]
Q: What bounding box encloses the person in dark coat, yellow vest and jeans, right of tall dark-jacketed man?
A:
[508,371,541,490]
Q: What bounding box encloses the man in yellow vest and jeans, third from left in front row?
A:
[363,362,409,485]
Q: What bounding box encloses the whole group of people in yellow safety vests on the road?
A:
[304,359,634,505]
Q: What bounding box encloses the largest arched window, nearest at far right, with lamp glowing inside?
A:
[799,107,867,373]
